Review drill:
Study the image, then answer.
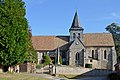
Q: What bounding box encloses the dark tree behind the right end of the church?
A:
[106,23,120,60]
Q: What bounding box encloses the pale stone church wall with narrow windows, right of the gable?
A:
[86,47,113,69]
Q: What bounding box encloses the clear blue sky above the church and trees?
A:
[24,0,120,36]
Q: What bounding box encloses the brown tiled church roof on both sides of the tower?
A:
[32,33,114,51]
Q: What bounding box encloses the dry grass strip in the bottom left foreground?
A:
[0,73,49,80]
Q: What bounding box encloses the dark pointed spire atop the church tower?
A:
[70,11,83,30]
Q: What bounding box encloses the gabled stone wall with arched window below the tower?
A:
[69,39,84,66]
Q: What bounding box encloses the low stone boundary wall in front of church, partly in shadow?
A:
[53,66,114,76]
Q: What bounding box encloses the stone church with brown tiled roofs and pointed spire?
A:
[32,12,116,70]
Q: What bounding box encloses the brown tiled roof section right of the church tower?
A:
[83,33,114,46]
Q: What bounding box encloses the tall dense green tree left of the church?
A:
[0,0,31,71]
